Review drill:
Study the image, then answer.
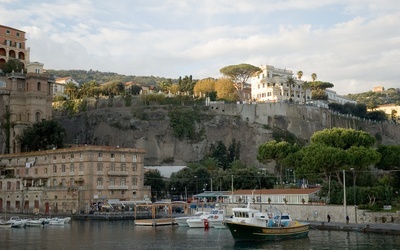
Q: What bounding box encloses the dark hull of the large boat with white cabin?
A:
[225,221,310,241]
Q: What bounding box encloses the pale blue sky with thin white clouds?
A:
[0,0,400,95]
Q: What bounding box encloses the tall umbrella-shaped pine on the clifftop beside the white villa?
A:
[219,63,262,100]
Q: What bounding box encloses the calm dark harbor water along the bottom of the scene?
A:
[0,221,400,250]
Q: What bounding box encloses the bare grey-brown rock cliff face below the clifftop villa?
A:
[54,103,400,166]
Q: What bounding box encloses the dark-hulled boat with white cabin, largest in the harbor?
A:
[224,198,310,241]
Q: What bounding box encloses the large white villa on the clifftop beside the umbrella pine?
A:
[250,65,311,103]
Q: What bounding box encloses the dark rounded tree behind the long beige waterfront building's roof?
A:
[18,120,65,152]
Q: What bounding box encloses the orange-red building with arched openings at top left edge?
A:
[0,25,30,67]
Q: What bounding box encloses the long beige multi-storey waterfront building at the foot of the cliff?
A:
[0,146,151,214]
